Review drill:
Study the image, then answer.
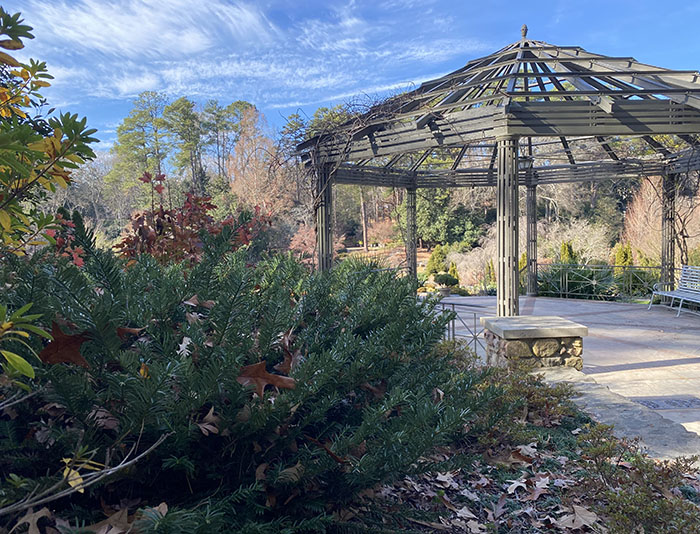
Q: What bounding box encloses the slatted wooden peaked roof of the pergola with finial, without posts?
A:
[299,26,700,191]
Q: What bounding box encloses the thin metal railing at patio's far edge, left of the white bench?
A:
[537,263,680,300]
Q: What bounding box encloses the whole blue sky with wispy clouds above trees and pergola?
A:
[8,0,700,148]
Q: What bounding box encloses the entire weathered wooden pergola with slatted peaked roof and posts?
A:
[298,26,700,316]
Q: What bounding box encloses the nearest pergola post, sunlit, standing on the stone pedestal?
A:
[496,136,519,317]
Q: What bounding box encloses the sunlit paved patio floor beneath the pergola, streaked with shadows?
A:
[443,297,700,454]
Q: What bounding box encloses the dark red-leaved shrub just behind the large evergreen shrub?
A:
[115,173,270,263]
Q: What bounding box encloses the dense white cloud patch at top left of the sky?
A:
[19,0,277,59]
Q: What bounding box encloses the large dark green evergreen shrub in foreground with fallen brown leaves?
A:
[0,224,496,534]
